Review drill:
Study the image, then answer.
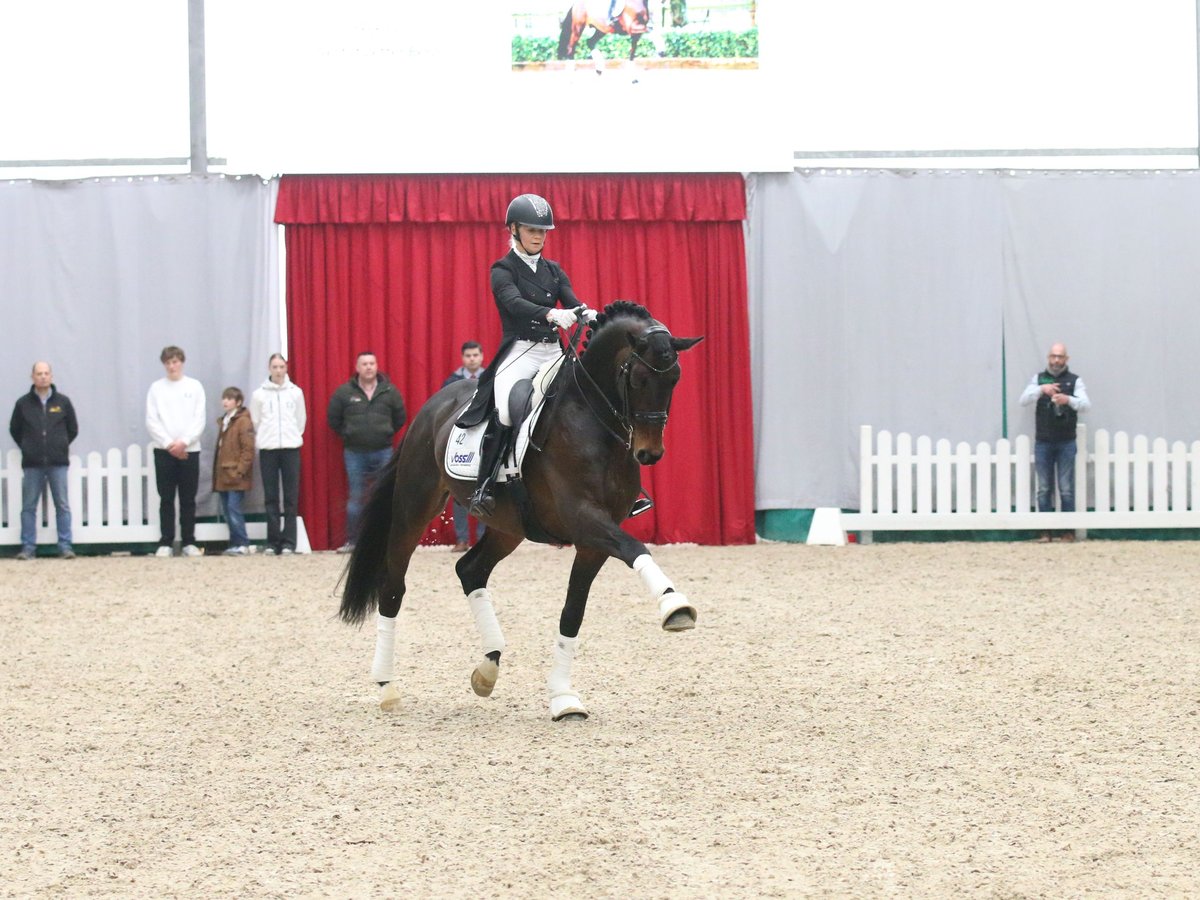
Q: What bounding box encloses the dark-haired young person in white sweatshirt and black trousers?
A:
[146,346,208,557]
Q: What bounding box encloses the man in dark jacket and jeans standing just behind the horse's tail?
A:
[328,352,406,553]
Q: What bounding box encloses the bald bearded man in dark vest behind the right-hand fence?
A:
[1021,343,1092,544]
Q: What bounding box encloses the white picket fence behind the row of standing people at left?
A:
[0,444,311,553]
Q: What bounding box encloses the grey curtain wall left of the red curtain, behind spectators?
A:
[0,175,281,514]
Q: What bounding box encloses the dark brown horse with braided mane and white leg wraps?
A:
[338,300,704,721]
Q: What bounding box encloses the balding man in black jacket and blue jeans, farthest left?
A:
[8,362,79,559]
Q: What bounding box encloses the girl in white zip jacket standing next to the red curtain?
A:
[250,353,308,556]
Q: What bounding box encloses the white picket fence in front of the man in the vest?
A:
[809,425,1200,544]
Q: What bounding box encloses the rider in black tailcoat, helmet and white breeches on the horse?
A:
[458,193,596,516]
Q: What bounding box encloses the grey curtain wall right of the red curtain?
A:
[746,170,1200,509]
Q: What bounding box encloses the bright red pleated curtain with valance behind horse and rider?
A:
[275,175,755,548]
